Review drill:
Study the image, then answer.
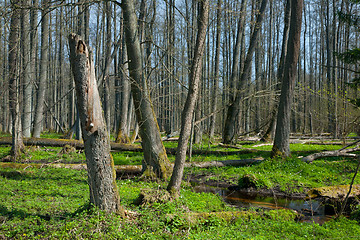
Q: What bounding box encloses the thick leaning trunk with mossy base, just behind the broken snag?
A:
[121,0,171,179]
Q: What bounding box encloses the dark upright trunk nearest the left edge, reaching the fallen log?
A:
[8,0,24,161]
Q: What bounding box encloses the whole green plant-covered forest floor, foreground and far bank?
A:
[0,132,360,239]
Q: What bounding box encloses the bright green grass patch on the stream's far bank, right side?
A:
[186,158,360,193]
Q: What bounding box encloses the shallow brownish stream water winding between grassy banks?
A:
[194,185,333,224]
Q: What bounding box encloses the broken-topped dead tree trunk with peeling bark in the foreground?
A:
[69,34,124,215]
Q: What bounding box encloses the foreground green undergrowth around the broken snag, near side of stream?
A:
[0,168,360,239]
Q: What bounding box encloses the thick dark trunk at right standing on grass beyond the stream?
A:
[271,0,303,157]
